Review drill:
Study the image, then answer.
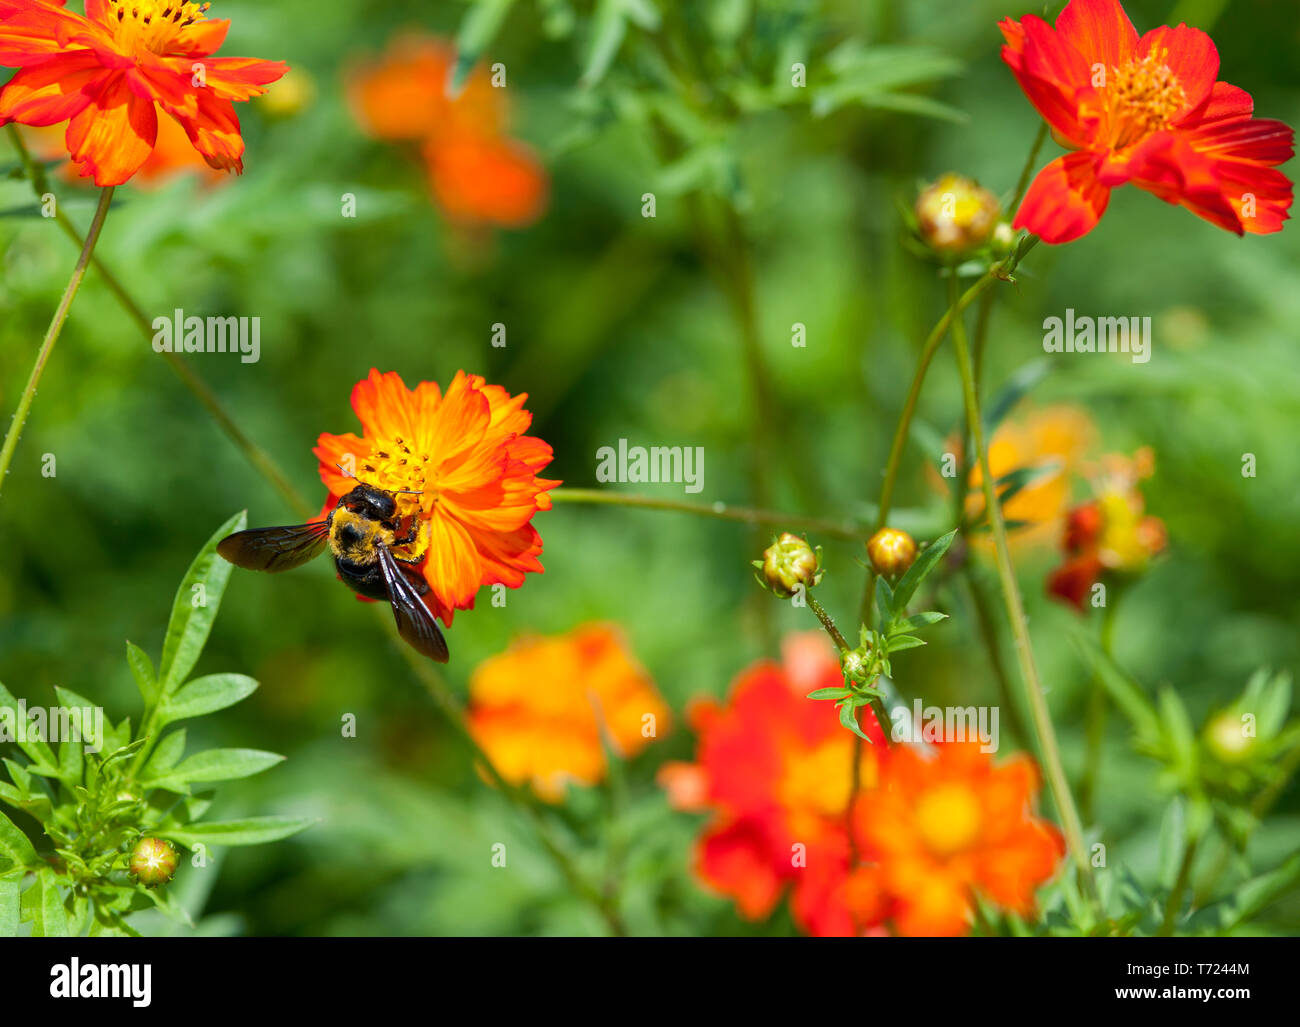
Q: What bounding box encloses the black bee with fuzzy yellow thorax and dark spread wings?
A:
[217,482,447,663]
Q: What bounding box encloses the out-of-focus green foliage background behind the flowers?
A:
[0,0,1300,935]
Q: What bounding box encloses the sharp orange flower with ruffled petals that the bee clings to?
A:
[312,369,559,627]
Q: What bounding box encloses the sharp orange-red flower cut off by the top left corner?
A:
[0,0,289,186]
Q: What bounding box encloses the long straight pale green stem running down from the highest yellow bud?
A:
[949,269,1095,896]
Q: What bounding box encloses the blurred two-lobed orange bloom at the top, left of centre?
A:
[348,35,549,228]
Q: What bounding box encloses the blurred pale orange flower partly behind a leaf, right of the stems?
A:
[948,404,1097,547]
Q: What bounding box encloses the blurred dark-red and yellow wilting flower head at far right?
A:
[1048,446,1167,611]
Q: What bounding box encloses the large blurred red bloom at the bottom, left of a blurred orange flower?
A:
[659,633,887,935]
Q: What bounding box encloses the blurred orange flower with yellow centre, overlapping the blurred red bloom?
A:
[855,742,1065,936]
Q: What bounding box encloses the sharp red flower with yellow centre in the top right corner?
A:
[998,0,1295,243]
